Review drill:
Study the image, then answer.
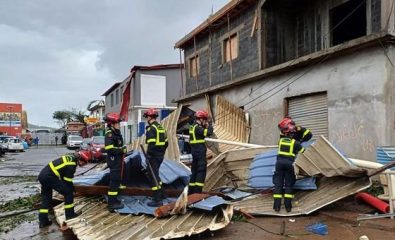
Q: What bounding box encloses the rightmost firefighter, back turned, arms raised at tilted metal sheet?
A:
[273,118,304,212]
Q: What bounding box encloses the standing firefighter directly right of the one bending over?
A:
[104,113,126,211]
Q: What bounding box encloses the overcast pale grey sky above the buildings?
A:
[0,0,229,127]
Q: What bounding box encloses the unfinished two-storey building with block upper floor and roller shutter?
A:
[175,0,395,160]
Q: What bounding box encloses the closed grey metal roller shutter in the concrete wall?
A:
[288,93,328,139]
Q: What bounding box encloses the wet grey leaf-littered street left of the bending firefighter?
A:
[0,146,74,239]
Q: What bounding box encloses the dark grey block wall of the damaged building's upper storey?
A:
[184,0,395,94]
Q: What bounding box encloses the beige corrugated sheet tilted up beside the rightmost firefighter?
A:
[295,136,366,177]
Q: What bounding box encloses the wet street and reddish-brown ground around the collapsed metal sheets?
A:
[0,147,395,240]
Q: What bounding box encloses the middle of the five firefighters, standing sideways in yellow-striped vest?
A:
[143,108,168,207]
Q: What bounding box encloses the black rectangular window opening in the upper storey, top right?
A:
[329,0,366,46]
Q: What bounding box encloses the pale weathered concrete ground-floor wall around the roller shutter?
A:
[182,47,395,160]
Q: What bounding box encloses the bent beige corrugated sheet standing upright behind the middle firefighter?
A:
[128,104,182,161]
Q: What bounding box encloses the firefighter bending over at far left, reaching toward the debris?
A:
[38,152,89,228]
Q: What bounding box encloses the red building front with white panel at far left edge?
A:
[0,103,22,136]
